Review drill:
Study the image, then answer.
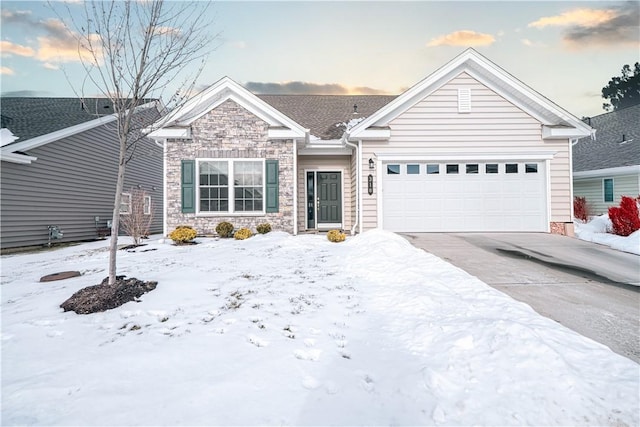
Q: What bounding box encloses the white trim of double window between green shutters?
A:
[195,157,267,216]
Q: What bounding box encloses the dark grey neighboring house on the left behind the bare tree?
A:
[0,97,163,249]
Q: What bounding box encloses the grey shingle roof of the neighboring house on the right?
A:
[573,104,640,172]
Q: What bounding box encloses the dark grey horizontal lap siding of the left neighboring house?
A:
[0,126,162,249]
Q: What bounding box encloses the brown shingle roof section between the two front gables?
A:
[256,95,396,140]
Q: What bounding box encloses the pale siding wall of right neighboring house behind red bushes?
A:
[573,175,640,216]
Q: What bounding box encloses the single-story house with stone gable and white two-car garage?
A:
[147,49,592,239]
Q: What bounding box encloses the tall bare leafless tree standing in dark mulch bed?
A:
[50,0,218,285]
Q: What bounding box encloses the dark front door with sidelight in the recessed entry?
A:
[307,172,342,228]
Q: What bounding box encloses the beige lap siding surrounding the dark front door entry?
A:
[298,156,355,231]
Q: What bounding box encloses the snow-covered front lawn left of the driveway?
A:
[1,231,640,426]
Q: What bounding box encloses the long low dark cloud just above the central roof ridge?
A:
[244,81,387,95]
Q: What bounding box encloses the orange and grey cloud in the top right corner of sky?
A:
[529,1,640,49]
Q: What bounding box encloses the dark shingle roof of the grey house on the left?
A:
[0,97,120,143]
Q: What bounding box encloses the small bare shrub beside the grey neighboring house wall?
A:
[120,188,153,246]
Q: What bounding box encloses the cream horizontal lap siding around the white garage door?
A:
[362,73,571,229]
